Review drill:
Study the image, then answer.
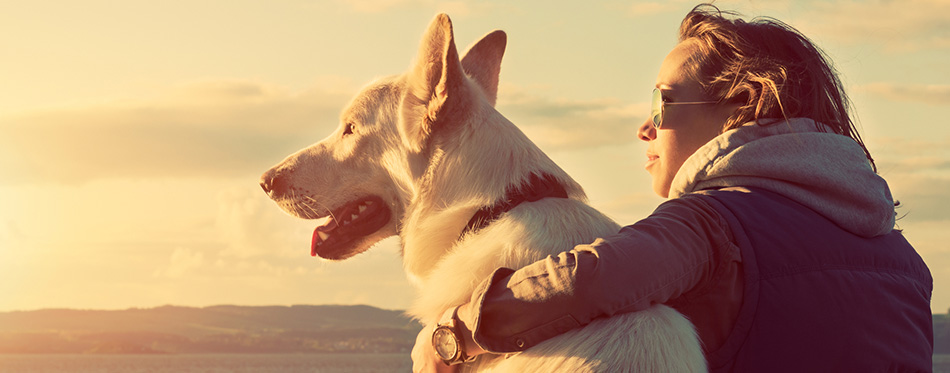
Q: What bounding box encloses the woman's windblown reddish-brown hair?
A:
[679,4,877,171]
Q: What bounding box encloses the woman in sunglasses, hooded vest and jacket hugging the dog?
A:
[414,5,933,372]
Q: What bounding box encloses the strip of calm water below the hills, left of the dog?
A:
[0,353,412,373]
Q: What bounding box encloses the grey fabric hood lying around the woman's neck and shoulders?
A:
[670,118,894,237]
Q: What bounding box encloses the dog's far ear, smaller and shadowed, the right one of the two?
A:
[462,30,508,106]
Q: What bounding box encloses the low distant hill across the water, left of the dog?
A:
[0,306,422,353]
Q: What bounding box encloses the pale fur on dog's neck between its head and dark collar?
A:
[400,100,586,285]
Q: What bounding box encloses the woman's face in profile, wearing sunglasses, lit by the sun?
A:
[637,40,738,197]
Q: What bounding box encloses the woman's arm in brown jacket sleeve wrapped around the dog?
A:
[458,196,734,355]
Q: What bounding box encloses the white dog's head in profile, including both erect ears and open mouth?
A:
[261,14,506,259]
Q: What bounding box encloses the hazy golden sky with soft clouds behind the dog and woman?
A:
[0,0,950,313]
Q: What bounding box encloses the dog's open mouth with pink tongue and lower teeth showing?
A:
[310,196,391,259]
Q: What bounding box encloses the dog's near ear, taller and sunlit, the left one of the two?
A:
[400,14,465,151]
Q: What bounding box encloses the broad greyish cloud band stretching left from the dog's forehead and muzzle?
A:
[0,81,356,183]
